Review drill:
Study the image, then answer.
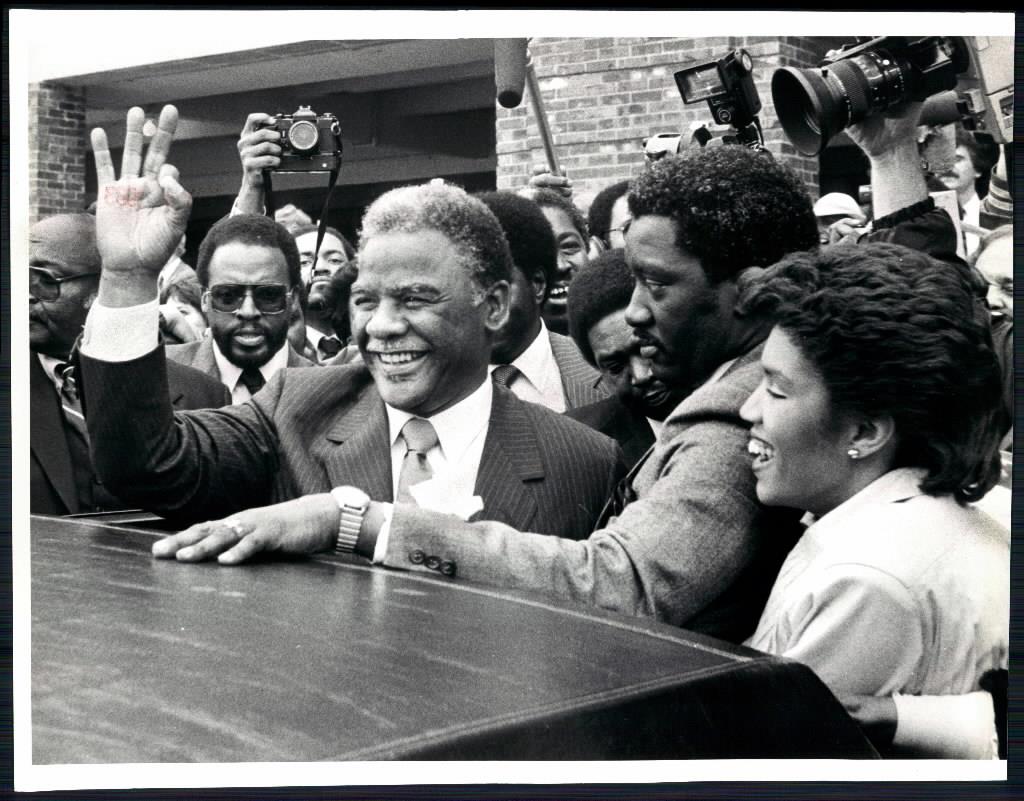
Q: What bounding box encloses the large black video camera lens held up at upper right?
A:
[771,51,907,156]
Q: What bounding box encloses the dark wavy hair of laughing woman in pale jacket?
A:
[737,244,1006,503]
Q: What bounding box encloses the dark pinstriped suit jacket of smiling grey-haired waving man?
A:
[82,349,623,538]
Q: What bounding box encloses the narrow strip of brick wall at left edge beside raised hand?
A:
[29,83,87,223]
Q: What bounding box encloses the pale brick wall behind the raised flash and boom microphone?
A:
[497,37,821,206]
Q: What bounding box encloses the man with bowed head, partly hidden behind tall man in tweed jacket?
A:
[568,247,683,467]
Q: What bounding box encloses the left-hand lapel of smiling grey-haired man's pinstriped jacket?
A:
[327,383,394,501]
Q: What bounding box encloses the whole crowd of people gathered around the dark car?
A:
[30,91,1013,757]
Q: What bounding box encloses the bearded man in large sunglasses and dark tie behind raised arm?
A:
[167,214,312,404]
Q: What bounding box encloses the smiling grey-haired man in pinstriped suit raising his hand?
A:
[75,107,622,540]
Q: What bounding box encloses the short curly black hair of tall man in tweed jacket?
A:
[629,147,818,283]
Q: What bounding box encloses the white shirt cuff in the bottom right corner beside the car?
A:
[893,691,999,759]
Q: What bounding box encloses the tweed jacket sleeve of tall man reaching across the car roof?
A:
[385,401,759,625]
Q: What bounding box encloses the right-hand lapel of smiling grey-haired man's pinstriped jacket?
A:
[475,387,544,531]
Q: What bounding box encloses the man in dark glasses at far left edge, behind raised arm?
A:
[29,213,228,514]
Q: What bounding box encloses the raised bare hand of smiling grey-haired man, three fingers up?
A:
[92,106,191,307]
